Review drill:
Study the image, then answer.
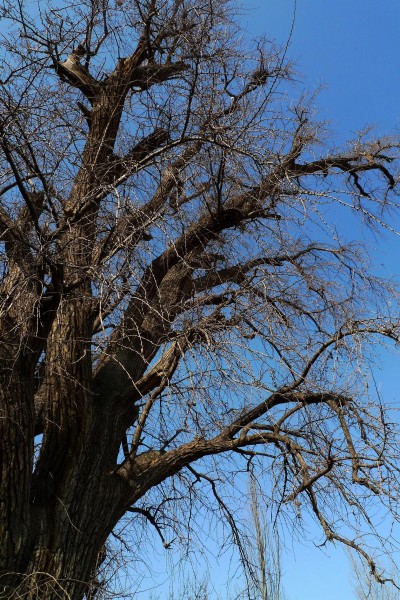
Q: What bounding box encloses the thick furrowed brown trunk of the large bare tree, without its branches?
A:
[0,295,146,600]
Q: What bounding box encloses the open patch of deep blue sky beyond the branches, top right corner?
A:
[243,0,400,139]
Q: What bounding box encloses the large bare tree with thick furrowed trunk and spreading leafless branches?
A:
[0,0,399,600]
